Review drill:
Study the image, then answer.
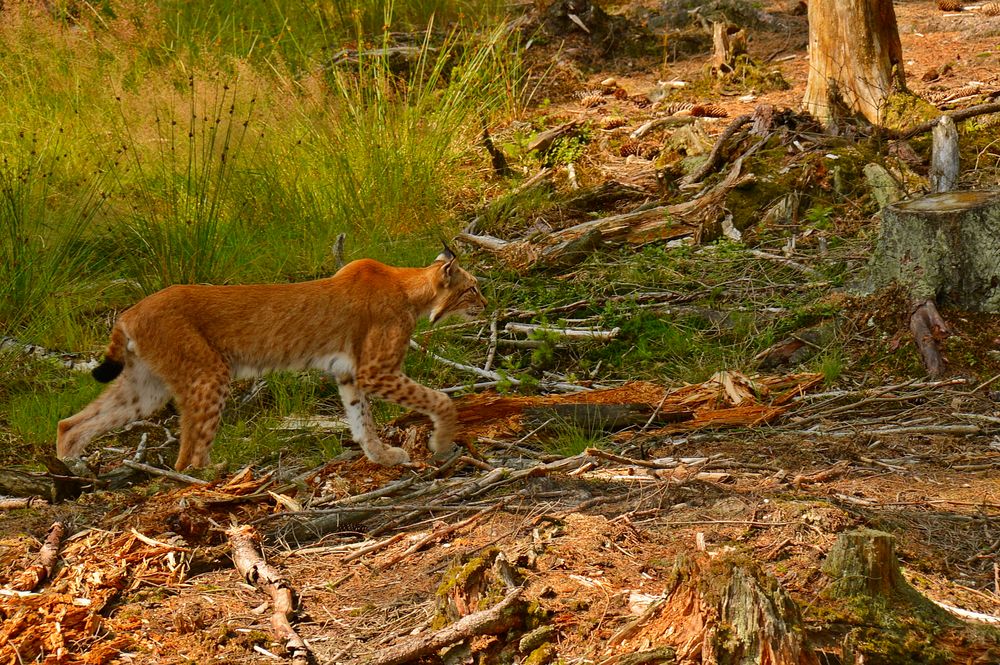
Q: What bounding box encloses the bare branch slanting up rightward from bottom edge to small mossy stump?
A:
[367,587,523,665]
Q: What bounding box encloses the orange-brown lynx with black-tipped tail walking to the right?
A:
[56,247,486,471]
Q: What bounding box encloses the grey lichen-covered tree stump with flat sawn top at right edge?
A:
[870,191,1000,312]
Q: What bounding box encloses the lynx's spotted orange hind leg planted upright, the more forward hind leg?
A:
[174,360,229,471]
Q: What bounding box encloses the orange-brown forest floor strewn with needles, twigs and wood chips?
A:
[0,2,1000,665]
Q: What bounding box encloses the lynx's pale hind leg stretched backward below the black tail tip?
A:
[56,357,170,459]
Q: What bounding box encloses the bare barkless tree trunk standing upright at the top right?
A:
[802,0,906,125]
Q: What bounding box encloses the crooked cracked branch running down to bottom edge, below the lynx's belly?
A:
[226,525,311,665]
